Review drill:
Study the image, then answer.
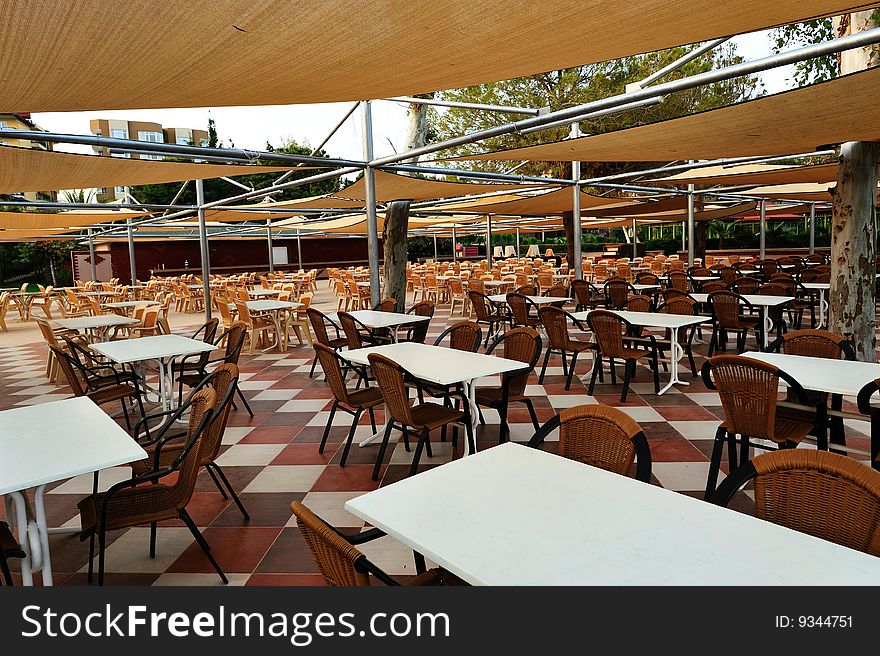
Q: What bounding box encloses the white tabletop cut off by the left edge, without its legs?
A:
[0,396,147,494]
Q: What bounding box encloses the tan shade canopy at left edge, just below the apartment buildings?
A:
[0,145,290,194]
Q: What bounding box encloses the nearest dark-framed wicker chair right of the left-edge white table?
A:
[77,388,228,585]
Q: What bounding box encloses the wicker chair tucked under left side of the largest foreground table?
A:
[290,501,466,587]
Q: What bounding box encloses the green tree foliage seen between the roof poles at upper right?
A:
[429,44,761,176]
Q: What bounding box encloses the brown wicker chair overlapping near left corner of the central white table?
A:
[369,353,475,481]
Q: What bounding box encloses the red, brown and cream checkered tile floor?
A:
[0,288,868,585]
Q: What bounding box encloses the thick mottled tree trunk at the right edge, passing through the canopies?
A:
[828,10,880,362]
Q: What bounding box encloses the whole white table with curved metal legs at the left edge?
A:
[0,396,147,585]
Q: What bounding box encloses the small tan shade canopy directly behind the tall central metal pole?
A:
[333,171,541,203]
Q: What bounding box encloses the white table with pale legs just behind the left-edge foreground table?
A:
[92,335,217,410]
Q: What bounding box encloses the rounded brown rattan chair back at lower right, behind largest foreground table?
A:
[712,449,880,556]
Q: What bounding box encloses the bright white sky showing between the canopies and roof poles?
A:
[33,32,793,169]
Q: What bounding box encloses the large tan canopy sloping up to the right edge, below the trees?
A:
[459,68,880,162]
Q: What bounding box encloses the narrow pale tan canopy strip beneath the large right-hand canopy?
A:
[641,164,837,185]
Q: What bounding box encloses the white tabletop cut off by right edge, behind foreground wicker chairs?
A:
[743,352,880,396]
